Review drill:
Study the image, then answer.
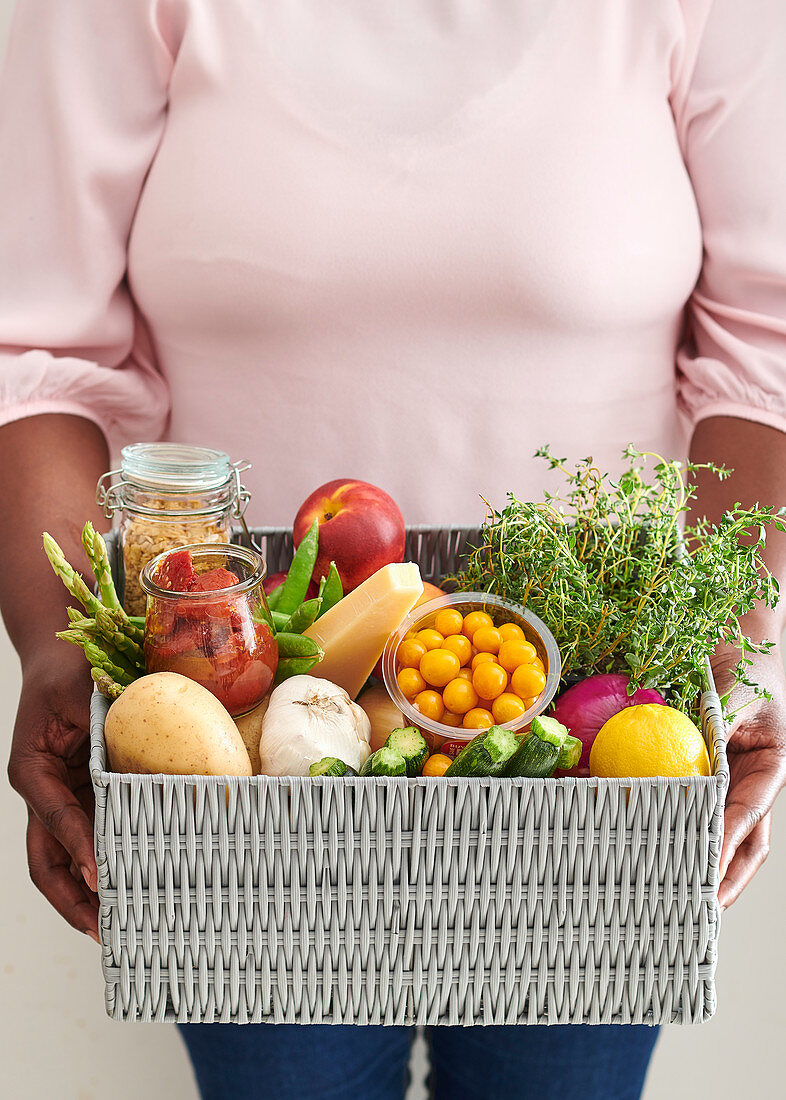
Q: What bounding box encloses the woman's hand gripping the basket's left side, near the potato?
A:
[8,640,98,943]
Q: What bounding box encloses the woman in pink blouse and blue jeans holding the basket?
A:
[0,0,786,1100]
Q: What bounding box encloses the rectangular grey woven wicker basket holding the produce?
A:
[90,528,728,1024]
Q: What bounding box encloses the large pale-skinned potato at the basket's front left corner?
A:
[104,672,252,776]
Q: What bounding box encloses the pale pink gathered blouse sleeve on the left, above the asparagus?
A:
[0,0,182,442]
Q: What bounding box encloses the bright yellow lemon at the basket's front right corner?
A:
[589,703,710,779]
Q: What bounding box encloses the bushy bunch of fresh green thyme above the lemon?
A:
[455,448,786,710]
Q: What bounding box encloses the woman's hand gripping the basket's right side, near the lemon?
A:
[712,650,786,909]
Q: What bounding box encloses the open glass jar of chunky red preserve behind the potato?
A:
[140,545,278,717]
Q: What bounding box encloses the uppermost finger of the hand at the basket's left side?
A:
[9,751,98,892]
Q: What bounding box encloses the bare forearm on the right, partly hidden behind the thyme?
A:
[690,417,786,641]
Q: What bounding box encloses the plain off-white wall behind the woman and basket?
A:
[0,0,786,1100]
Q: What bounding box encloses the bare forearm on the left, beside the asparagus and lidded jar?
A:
[0,415,109,667]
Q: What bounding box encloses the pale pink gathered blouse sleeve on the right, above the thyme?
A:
[672,0,786,431]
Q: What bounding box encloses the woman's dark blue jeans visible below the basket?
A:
[180,1024,657,1100]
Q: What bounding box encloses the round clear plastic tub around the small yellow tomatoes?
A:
[383,592,562,748]
